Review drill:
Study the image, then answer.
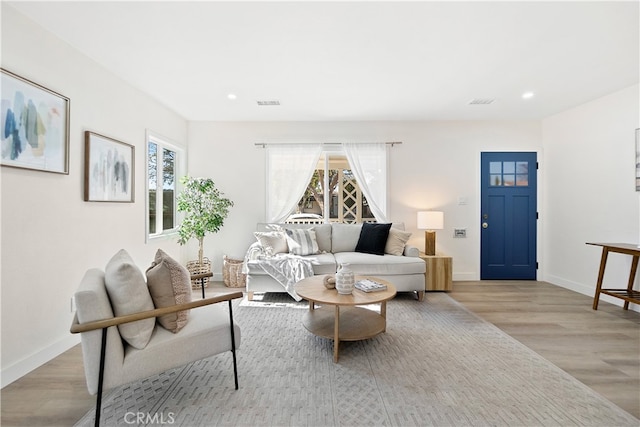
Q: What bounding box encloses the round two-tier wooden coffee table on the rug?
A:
[295,275,396,362]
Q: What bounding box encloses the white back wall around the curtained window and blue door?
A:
[189,121,542,280]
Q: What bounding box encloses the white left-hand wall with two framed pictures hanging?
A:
[0,3,187,386]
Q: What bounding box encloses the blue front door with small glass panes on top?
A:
[480,152,537,280]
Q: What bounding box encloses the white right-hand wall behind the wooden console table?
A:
[542,85,640,309]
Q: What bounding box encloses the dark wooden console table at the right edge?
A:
[587,243,640,310]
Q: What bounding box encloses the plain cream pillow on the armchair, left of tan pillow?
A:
[104,249,156,349]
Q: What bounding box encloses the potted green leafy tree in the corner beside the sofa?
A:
[177,176,233,283]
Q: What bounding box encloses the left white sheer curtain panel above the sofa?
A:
[266,144,322,222]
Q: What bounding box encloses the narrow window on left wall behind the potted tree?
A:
[147,133,184,241]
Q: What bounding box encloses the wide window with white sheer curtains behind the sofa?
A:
[266,143,388,223]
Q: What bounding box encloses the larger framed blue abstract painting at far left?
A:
[0,68,70,175]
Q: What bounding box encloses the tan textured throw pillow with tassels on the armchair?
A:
[146,249,191,333]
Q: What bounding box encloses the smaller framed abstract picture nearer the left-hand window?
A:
[84,131,135,203]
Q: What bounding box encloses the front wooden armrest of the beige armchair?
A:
[71,291,243,334]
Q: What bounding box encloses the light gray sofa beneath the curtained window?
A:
[245,223,426,301]
